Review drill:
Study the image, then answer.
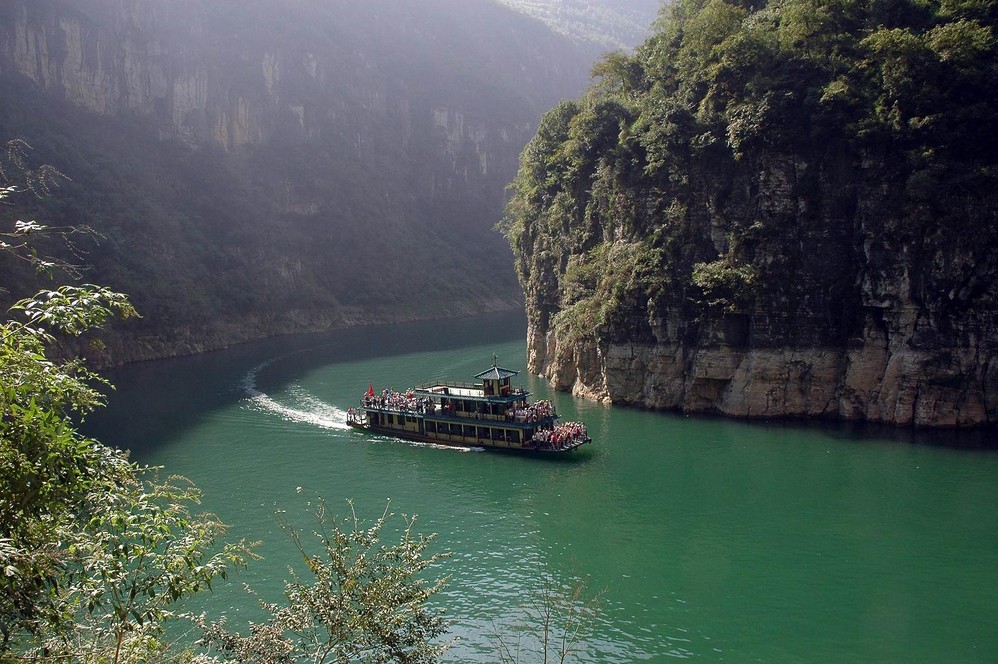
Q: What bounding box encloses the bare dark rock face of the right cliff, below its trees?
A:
[527,146,998,427]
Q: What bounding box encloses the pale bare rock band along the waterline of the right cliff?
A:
[528,294,998,427]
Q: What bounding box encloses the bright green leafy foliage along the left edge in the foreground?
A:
[0,166,252,662]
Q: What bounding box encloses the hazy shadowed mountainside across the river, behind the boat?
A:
[0,0,599,361]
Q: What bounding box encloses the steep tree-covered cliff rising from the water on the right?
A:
[504,0,998,426]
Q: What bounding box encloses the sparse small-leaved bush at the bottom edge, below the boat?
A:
[197,501,449,664]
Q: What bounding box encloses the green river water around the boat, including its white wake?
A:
[87,316,998,662]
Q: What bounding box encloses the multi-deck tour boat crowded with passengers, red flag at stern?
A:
[347,360,592,453]
